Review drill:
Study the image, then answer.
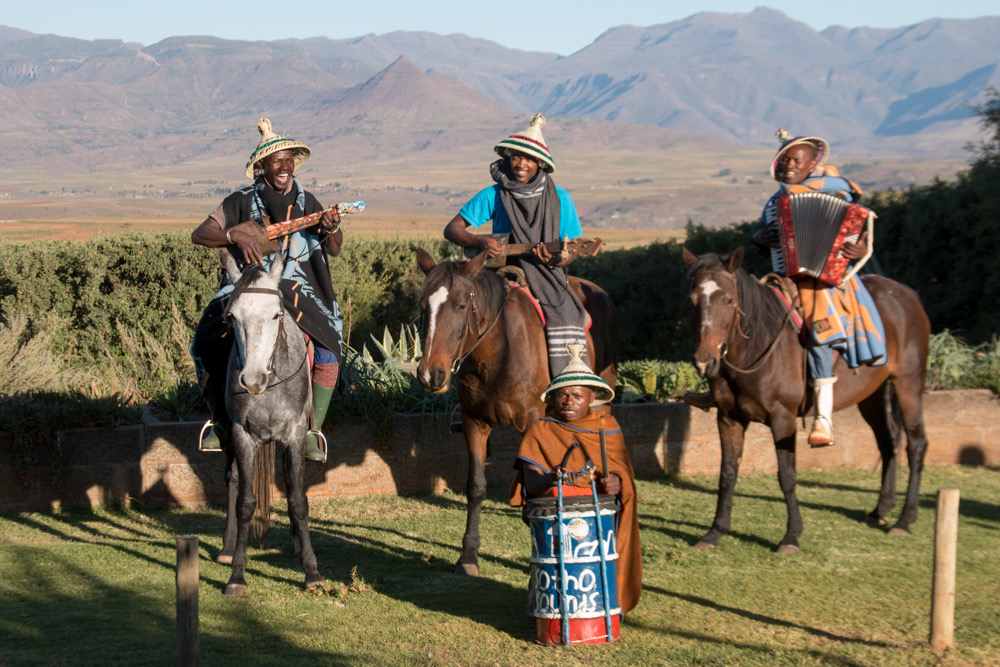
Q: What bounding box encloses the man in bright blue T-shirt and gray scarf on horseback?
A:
[444,113,586,377]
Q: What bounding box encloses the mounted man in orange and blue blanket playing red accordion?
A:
[684,129,885,447]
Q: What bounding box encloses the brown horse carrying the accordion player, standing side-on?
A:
[684,247,930,553]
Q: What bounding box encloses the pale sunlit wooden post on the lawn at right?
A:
[931,489,959,651]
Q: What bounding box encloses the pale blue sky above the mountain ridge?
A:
[0,0,1000,55]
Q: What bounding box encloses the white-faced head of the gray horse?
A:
[219,251,285,394]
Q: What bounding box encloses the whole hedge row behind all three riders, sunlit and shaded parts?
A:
[0,218,1000,376]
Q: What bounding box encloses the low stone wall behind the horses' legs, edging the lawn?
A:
[0,390,1000,514]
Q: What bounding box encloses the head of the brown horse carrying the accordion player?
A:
[683,246,743,379]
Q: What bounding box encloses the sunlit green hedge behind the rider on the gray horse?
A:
[0,231,448,363]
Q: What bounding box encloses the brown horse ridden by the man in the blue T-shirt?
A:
[417,250,619,575]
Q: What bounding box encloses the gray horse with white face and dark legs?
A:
[217,250,325,595]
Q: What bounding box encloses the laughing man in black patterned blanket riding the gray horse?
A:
[191,118,344,462]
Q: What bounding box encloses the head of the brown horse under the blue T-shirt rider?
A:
[417,250,499,394]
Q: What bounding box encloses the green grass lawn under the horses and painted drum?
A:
[0,467,1000,665]
